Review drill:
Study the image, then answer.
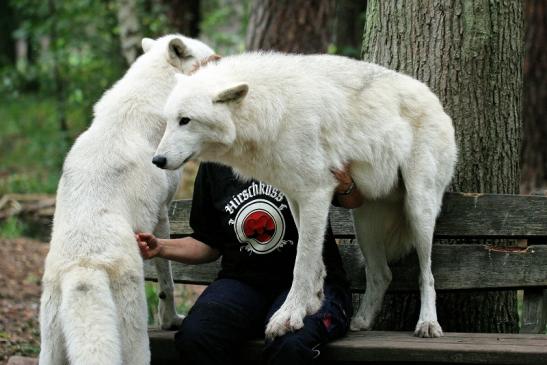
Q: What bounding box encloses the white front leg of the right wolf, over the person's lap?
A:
[266,189,332,339]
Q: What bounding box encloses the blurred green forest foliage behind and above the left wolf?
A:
[0,0,255,202]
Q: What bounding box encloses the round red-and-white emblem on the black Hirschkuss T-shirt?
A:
[234,199,285,254]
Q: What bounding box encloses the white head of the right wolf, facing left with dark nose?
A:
[152,72,249,170]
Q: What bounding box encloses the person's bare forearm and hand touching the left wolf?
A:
[135,233,220,264]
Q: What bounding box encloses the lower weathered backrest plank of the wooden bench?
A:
[145,243,547,292]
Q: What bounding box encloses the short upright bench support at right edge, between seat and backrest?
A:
[520,288,547,334]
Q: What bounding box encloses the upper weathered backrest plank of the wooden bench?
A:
[170,193,547,242]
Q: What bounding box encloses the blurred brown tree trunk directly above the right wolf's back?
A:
[245,0,335,53]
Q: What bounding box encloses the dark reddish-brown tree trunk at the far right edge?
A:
[521,0,547,193]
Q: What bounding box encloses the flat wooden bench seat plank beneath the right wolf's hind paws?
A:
[149,330,547,365]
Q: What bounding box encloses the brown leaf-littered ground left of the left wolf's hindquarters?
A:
[0,238,48,365]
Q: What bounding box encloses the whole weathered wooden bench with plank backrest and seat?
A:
[145,193,547,365]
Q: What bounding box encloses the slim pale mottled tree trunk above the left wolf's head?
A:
[117,0,142,65]
